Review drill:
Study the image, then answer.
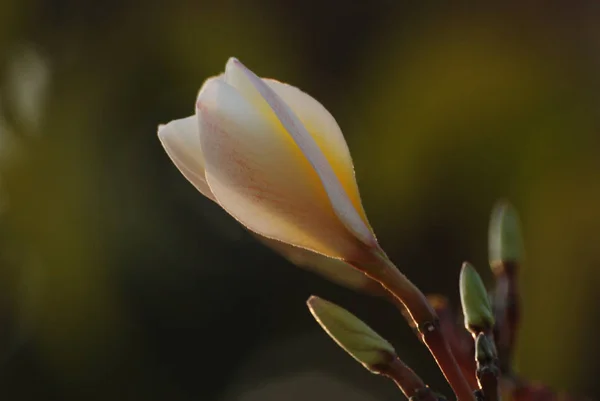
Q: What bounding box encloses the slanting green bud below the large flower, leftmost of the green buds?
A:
[306,295,396,374]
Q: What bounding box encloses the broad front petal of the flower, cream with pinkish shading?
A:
[196,80,364,259]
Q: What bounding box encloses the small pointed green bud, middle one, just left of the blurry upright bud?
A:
[459,262,494,331]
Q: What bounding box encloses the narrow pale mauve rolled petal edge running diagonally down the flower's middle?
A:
[230,59,377,247]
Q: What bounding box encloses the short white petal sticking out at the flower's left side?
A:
[158,115,215,201]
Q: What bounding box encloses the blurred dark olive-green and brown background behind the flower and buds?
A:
[0,0,600,401]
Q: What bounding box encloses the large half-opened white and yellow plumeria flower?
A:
[158,58,379,287]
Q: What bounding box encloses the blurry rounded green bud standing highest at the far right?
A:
[489,201,523,266]
